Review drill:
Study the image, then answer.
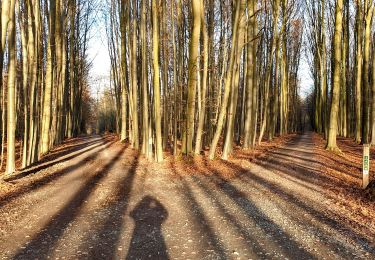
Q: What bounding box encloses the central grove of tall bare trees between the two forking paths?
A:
[105,0,304,161]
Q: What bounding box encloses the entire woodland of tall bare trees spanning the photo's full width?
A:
[0,0,375,174]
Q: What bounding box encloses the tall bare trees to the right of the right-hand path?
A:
[305,0,375,149]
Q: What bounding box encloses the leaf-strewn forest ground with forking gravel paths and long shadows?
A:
[0,133,375,259]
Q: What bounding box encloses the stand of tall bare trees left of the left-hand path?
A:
[0,0,93,174]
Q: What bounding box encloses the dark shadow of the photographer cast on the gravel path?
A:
[126,196,169,259]
